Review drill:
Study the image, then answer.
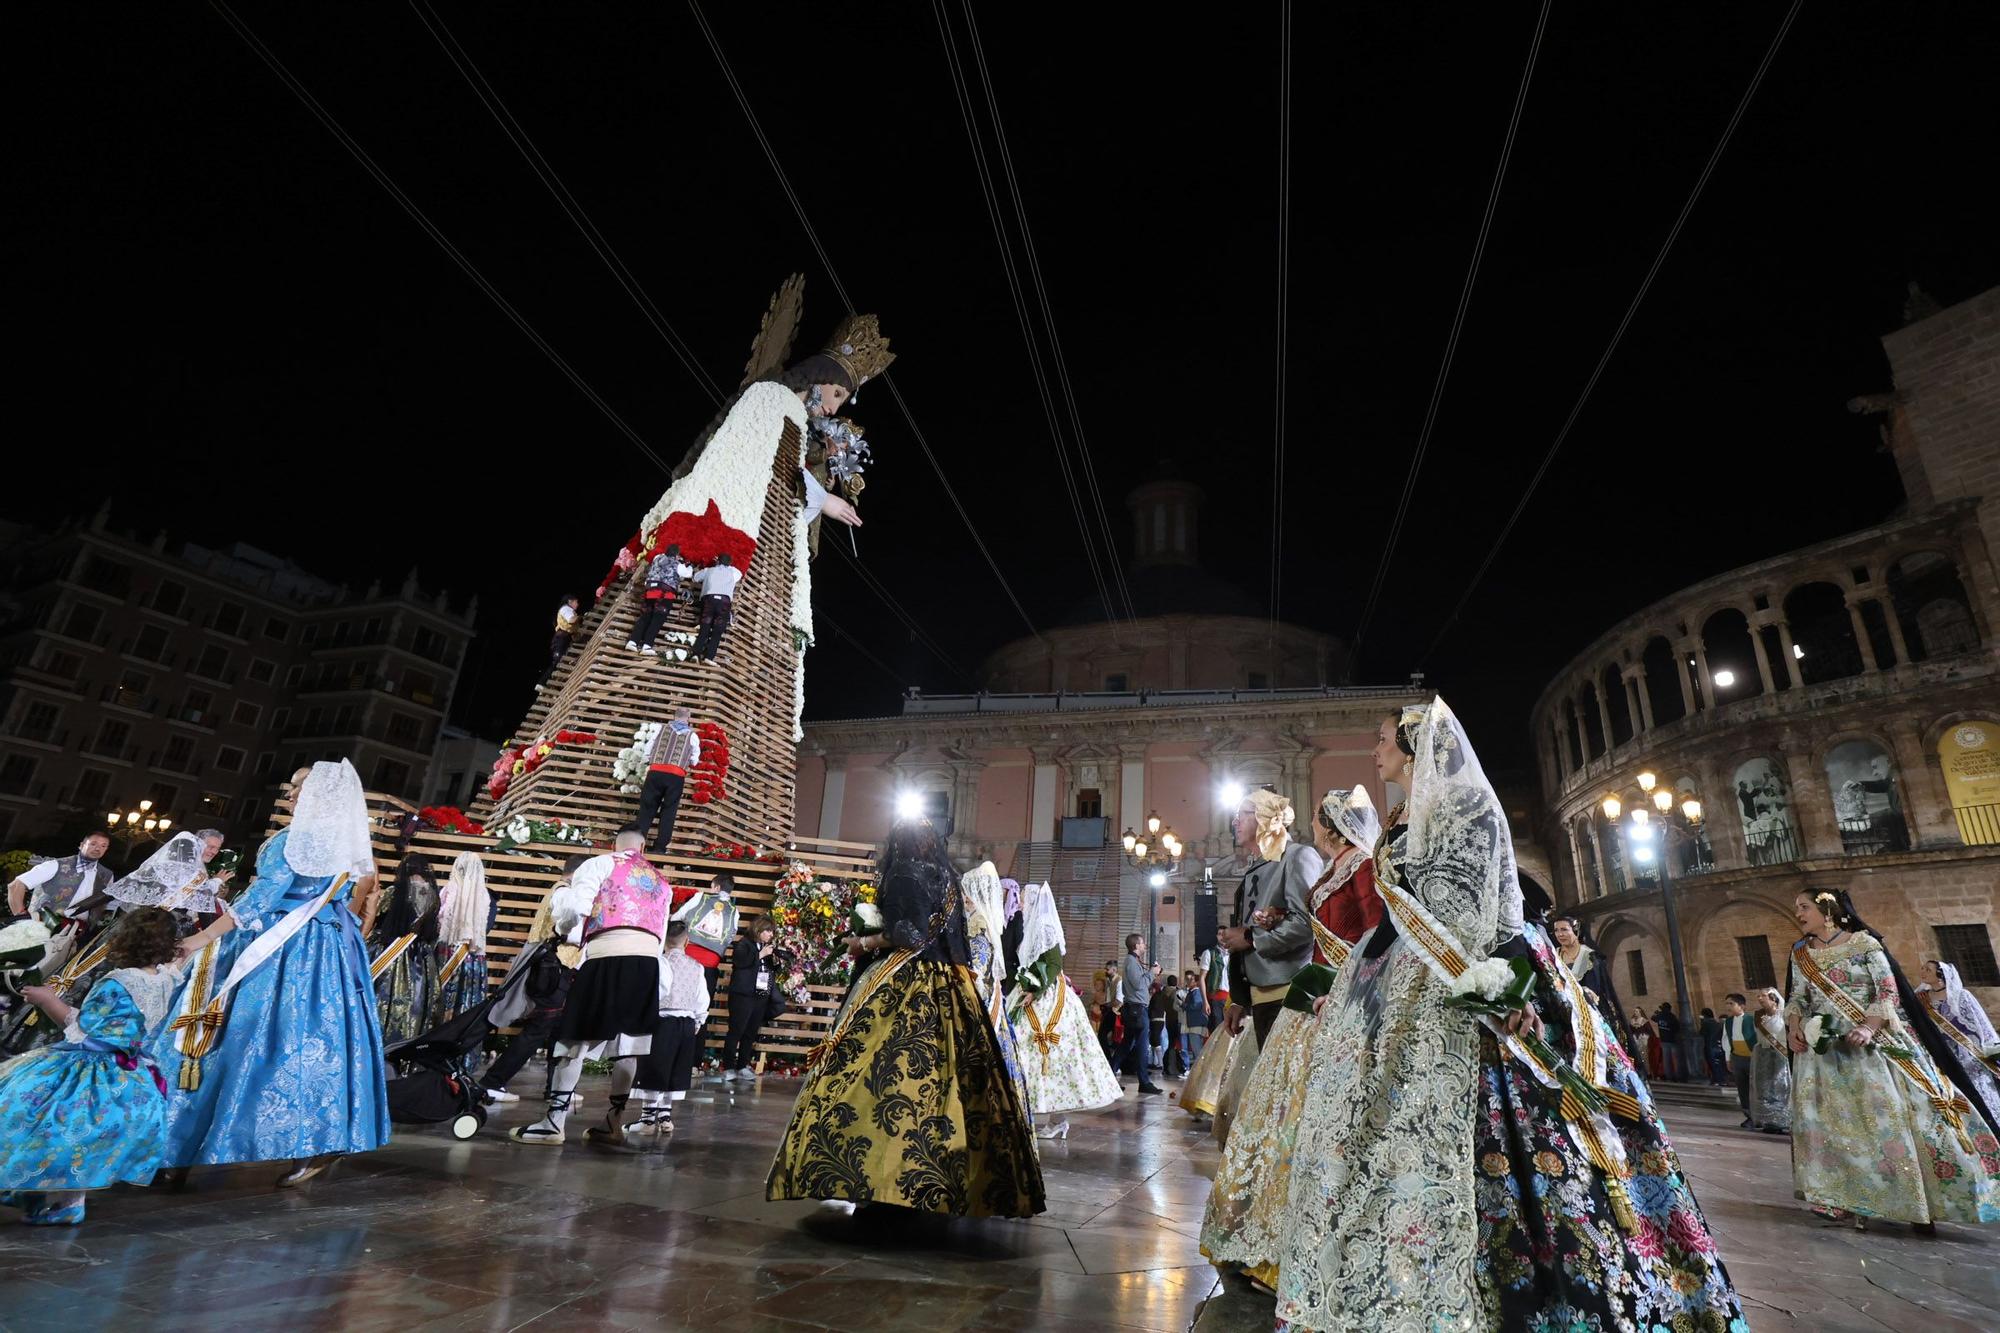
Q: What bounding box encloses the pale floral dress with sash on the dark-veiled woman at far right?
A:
[1784,931,2000,1223]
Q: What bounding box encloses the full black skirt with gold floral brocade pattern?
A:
[764,959,1046,1217]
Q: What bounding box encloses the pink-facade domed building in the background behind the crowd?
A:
[798,480,1424,975]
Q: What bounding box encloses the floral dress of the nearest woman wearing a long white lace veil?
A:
[1278,793,1748,1333]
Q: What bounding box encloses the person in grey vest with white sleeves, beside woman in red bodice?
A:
[1216,787,1326,1049]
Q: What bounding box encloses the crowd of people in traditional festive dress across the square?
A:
[0,701,2000,1331]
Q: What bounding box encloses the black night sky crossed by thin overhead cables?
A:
[19,0,2000,763]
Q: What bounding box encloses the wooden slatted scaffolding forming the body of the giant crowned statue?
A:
[274,276,874,1059]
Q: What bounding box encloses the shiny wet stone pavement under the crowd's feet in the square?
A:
[0,1079,2000,1333]
